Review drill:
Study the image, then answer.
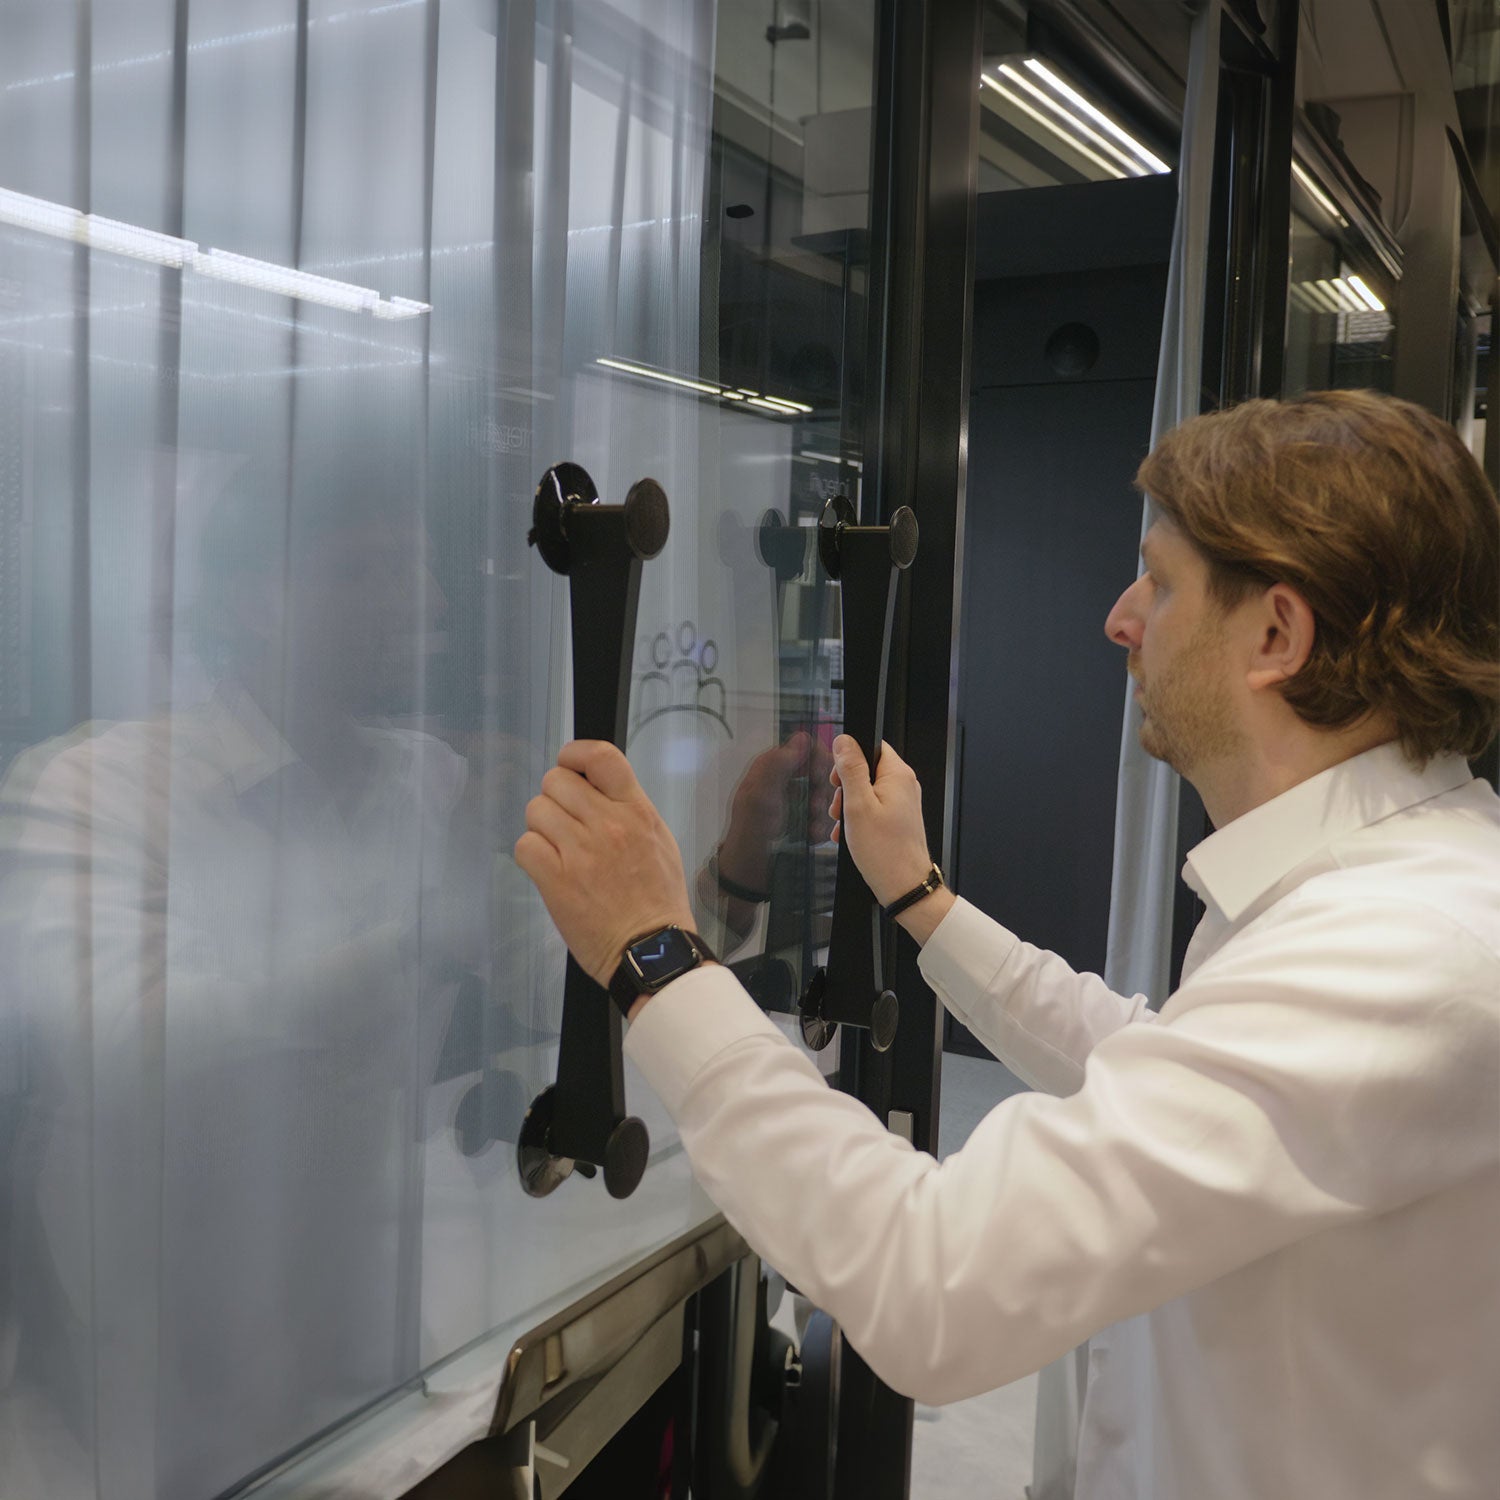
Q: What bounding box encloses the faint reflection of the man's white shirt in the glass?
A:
[0,687,467,1500]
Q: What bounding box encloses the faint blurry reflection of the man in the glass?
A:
[0,459,494,1500]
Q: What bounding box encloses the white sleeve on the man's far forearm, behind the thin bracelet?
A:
[918,897,1155,1094]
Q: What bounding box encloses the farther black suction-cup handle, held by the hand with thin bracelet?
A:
[801,495,917,1052]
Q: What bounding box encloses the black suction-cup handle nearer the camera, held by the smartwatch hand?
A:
[516,464,669,1199]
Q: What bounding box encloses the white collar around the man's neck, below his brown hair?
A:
[1182,741,1472,923]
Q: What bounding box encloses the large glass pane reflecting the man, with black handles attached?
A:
[0,0,875,1500]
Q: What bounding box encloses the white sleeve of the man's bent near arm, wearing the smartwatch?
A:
[627,905,1500,1403]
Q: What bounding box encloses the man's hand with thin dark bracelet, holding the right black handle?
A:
[828,735,932,906]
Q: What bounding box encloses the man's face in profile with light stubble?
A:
[1104,519,1244,780]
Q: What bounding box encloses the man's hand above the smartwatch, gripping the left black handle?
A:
[516,740,693,986]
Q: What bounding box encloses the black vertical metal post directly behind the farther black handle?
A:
[834,0,983,1500]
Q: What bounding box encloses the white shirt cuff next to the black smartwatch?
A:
[624,963,792,1119]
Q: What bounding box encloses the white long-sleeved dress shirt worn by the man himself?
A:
[627,746,1500,1500]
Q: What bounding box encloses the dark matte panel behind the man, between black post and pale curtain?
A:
[948,179,1175,1052]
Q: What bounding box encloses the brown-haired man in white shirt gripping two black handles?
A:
[516,393,1500,1500]
